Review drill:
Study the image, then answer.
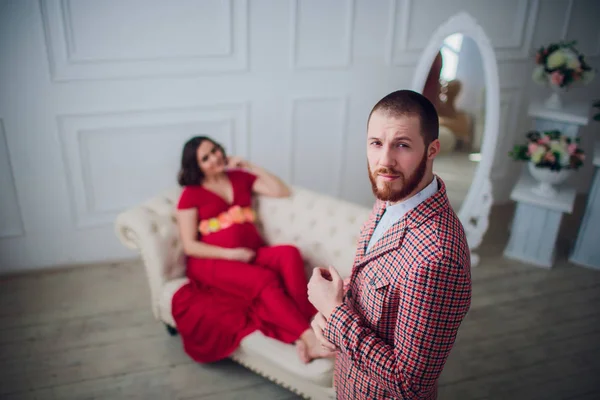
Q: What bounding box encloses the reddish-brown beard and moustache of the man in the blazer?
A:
[367,151,427,203]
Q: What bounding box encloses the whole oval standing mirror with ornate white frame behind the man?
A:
[412,12,500,266]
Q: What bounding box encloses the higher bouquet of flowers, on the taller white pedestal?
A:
[533,41,595,89]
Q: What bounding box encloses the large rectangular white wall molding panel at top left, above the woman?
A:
[40,0,249,81]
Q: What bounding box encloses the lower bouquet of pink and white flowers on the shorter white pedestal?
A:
[509,130,585,171]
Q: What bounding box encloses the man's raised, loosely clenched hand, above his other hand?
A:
[308,267,344,319]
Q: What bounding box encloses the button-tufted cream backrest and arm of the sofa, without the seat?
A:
[115,187,370,319]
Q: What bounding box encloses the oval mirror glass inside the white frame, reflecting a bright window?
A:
[422,33,486,212]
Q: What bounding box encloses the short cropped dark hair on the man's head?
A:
[367,90,440,146]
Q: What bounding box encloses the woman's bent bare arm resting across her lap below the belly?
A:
[177,208,254,262]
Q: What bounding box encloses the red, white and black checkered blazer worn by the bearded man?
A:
[324,177,471,400]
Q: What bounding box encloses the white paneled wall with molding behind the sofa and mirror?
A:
[0,0,600,272]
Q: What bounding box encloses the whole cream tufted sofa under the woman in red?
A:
[116,187,370,399]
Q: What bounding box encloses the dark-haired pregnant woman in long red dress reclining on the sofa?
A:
[172,136,333,363]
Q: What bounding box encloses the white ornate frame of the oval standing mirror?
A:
[412,12,500,267]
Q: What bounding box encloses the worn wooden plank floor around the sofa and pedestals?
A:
[0,204,600,400]
